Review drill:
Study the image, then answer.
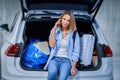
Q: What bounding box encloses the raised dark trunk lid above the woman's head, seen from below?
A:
[21,0,103,19]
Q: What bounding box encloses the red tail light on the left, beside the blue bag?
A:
[5,44,19,56]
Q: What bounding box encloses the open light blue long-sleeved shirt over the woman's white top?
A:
[44,28,80,70]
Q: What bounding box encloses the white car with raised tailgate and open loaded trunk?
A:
[0,0,113,80]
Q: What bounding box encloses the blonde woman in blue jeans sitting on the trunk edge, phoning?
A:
[46,11,80,80]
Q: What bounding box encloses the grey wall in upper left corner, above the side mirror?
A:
[0,0,20,27]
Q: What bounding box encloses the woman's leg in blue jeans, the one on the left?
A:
[47,58,59,80]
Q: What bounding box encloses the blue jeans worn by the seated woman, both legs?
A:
[48,57,71,80]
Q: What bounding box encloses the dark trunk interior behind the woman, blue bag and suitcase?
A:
[21,18,101,71]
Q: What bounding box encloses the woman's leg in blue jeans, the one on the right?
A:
[59,58,71,80]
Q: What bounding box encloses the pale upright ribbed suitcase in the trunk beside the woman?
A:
[80,34,95,66]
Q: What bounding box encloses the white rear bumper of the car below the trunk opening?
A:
[1,57,113,80]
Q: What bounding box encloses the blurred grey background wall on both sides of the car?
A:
[0,0,120,80]
